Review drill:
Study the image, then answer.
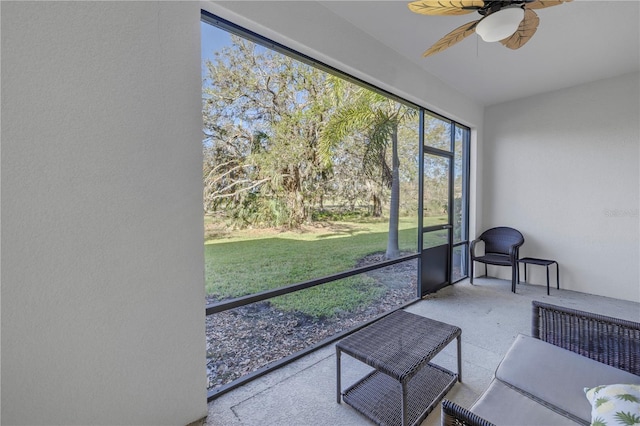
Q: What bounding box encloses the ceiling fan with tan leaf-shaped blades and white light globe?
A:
[409,0,572,57]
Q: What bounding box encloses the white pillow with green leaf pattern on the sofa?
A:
[584,385,640,426]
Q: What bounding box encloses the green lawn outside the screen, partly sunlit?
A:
[205,217,446,317]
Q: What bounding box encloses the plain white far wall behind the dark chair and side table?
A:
[482,73,640,302]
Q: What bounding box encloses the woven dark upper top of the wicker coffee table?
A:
[336,311,461,382]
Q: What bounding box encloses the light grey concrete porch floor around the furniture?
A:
[203,277,640,426]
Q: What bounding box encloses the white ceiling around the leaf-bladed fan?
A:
[319,0,640,105]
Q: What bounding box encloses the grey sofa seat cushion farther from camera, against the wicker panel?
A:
[496,335,640,422]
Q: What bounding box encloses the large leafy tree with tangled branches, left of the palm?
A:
[203,36,331,227]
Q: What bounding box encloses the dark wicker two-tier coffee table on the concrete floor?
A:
[336,311,462,426]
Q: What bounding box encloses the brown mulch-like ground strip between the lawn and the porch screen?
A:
[206,254,417,389]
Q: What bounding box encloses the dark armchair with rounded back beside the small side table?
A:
[469,226,524,293]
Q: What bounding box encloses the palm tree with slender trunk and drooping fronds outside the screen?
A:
[319,79,416,259]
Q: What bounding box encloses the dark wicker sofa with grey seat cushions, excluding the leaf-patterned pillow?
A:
[442,301,640,426]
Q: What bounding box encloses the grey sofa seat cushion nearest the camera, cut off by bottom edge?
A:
[470,379,584,426]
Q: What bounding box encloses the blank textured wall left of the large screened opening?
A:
[1,1,207,425]
